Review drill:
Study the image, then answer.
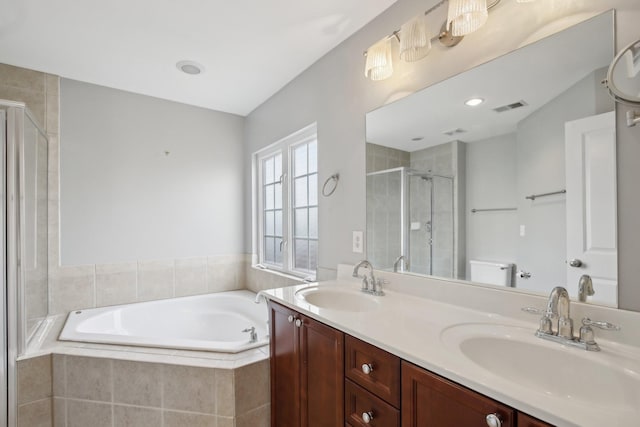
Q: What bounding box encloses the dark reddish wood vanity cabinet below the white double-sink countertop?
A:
[269,301,553,427]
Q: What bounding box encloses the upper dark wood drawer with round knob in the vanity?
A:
[344,335,400,407]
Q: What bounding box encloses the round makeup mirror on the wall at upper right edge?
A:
[607,40,640,104]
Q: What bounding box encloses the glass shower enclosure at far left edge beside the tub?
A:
[0,100,49,427]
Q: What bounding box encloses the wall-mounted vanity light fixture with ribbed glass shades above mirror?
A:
[364,0,500,80]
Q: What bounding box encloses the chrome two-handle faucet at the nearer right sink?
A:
[523,286,620,351]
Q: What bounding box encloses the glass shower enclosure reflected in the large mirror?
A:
[367,167,455,278]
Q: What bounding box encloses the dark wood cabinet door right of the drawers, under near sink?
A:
[401,362,515,427]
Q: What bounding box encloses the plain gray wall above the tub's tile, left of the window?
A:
[60,79,244,265]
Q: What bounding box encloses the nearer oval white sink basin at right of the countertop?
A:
[441,323,640,409]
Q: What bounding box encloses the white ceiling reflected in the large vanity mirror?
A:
[367,14,613,152]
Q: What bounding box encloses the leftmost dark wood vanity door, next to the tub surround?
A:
[269,302,300,427]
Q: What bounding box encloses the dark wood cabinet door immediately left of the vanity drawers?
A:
[300,316,344,427]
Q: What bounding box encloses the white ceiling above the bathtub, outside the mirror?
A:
[0,0,396,115]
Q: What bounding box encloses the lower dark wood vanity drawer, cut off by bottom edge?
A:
[344,380,400,427]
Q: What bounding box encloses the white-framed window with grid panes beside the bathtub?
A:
[254,125,318,276]
